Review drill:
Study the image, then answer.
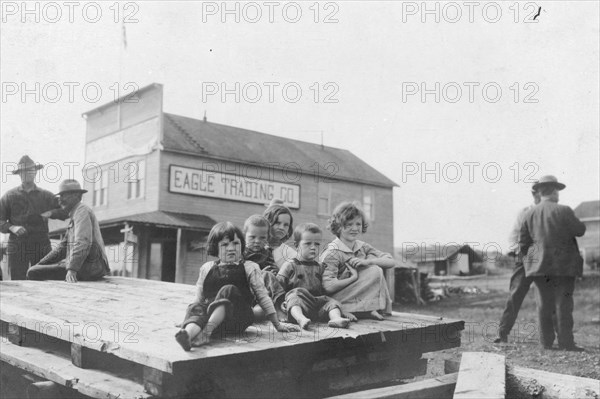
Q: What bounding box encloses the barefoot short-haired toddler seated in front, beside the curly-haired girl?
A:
[277,223,350,330]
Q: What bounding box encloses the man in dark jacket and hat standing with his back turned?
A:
[519,175,585,352]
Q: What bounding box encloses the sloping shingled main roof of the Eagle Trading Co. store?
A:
[163,113,397,187]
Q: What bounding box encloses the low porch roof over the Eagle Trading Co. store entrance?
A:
[49,211,217,235]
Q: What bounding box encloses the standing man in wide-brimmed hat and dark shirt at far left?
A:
[0,155,66,280]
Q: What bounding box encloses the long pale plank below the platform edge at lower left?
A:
[0,342,150,399]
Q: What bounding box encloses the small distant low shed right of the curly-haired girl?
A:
[404,244,484,276]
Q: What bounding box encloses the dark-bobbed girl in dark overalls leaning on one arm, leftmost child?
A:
[175,222,298,351]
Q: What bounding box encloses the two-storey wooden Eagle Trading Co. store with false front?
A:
[65,84,396,284]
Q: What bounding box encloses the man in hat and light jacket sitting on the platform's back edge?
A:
[27,179,110,283]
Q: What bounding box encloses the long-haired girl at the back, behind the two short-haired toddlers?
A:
[263,199,296,268]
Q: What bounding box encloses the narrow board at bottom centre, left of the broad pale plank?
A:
[328,373,458,399]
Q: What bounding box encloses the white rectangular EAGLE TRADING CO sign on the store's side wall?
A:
[169,165,300,209]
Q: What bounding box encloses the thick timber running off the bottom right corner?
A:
[507,366,600,399]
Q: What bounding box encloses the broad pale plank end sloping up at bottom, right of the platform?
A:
[454,352,506,399]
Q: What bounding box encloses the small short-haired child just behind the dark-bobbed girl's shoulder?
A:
[244,215,285,320]
